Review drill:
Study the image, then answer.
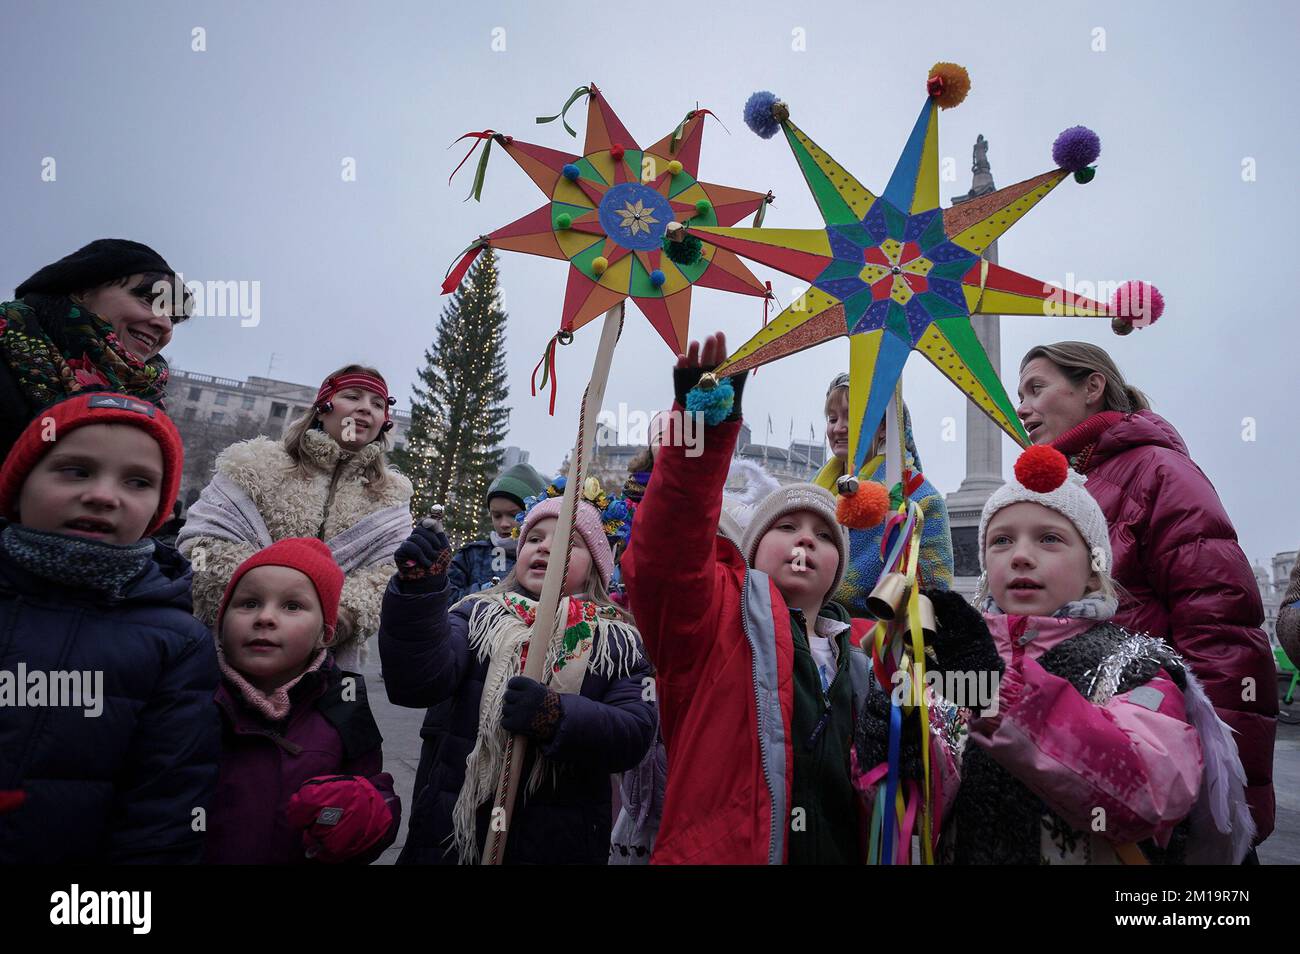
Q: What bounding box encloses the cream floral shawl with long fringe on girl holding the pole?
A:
[451,593,641,864]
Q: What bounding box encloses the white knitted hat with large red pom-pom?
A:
[979,446,1112,573]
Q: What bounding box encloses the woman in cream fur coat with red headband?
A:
[177,365,411,669]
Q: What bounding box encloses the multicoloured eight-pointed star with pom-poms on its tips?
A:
[689,64,1162,473]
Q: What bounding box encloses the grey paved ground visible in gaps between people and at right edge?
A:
[363,657,1300,864]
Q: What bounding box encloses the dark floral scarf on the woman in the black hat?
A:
[0,295,168,412]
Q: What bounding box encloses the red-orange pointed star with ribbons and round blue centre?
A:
[445,84,771,352]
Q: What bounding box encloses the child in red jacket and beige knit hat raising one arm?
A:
[623,334,871,864]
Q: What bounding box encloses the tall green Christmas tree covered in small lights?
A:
[393,248,510,547]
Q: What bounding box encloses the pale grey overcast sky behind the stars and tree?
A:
[0,0,1300,560]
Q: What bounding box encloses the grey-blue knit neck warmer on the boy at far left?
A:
[0,524,153,599]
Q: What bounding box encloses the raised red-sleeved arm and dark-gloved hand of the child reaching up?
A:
[623,334,745,678]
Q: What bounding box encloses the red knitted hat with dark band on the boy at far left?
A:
[0,391,185,537]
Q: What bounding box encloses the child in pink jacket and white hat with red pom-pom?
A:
[883,447,1255,864]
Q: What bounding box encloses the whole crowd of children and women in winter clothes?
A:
[0,239,1284,864]
